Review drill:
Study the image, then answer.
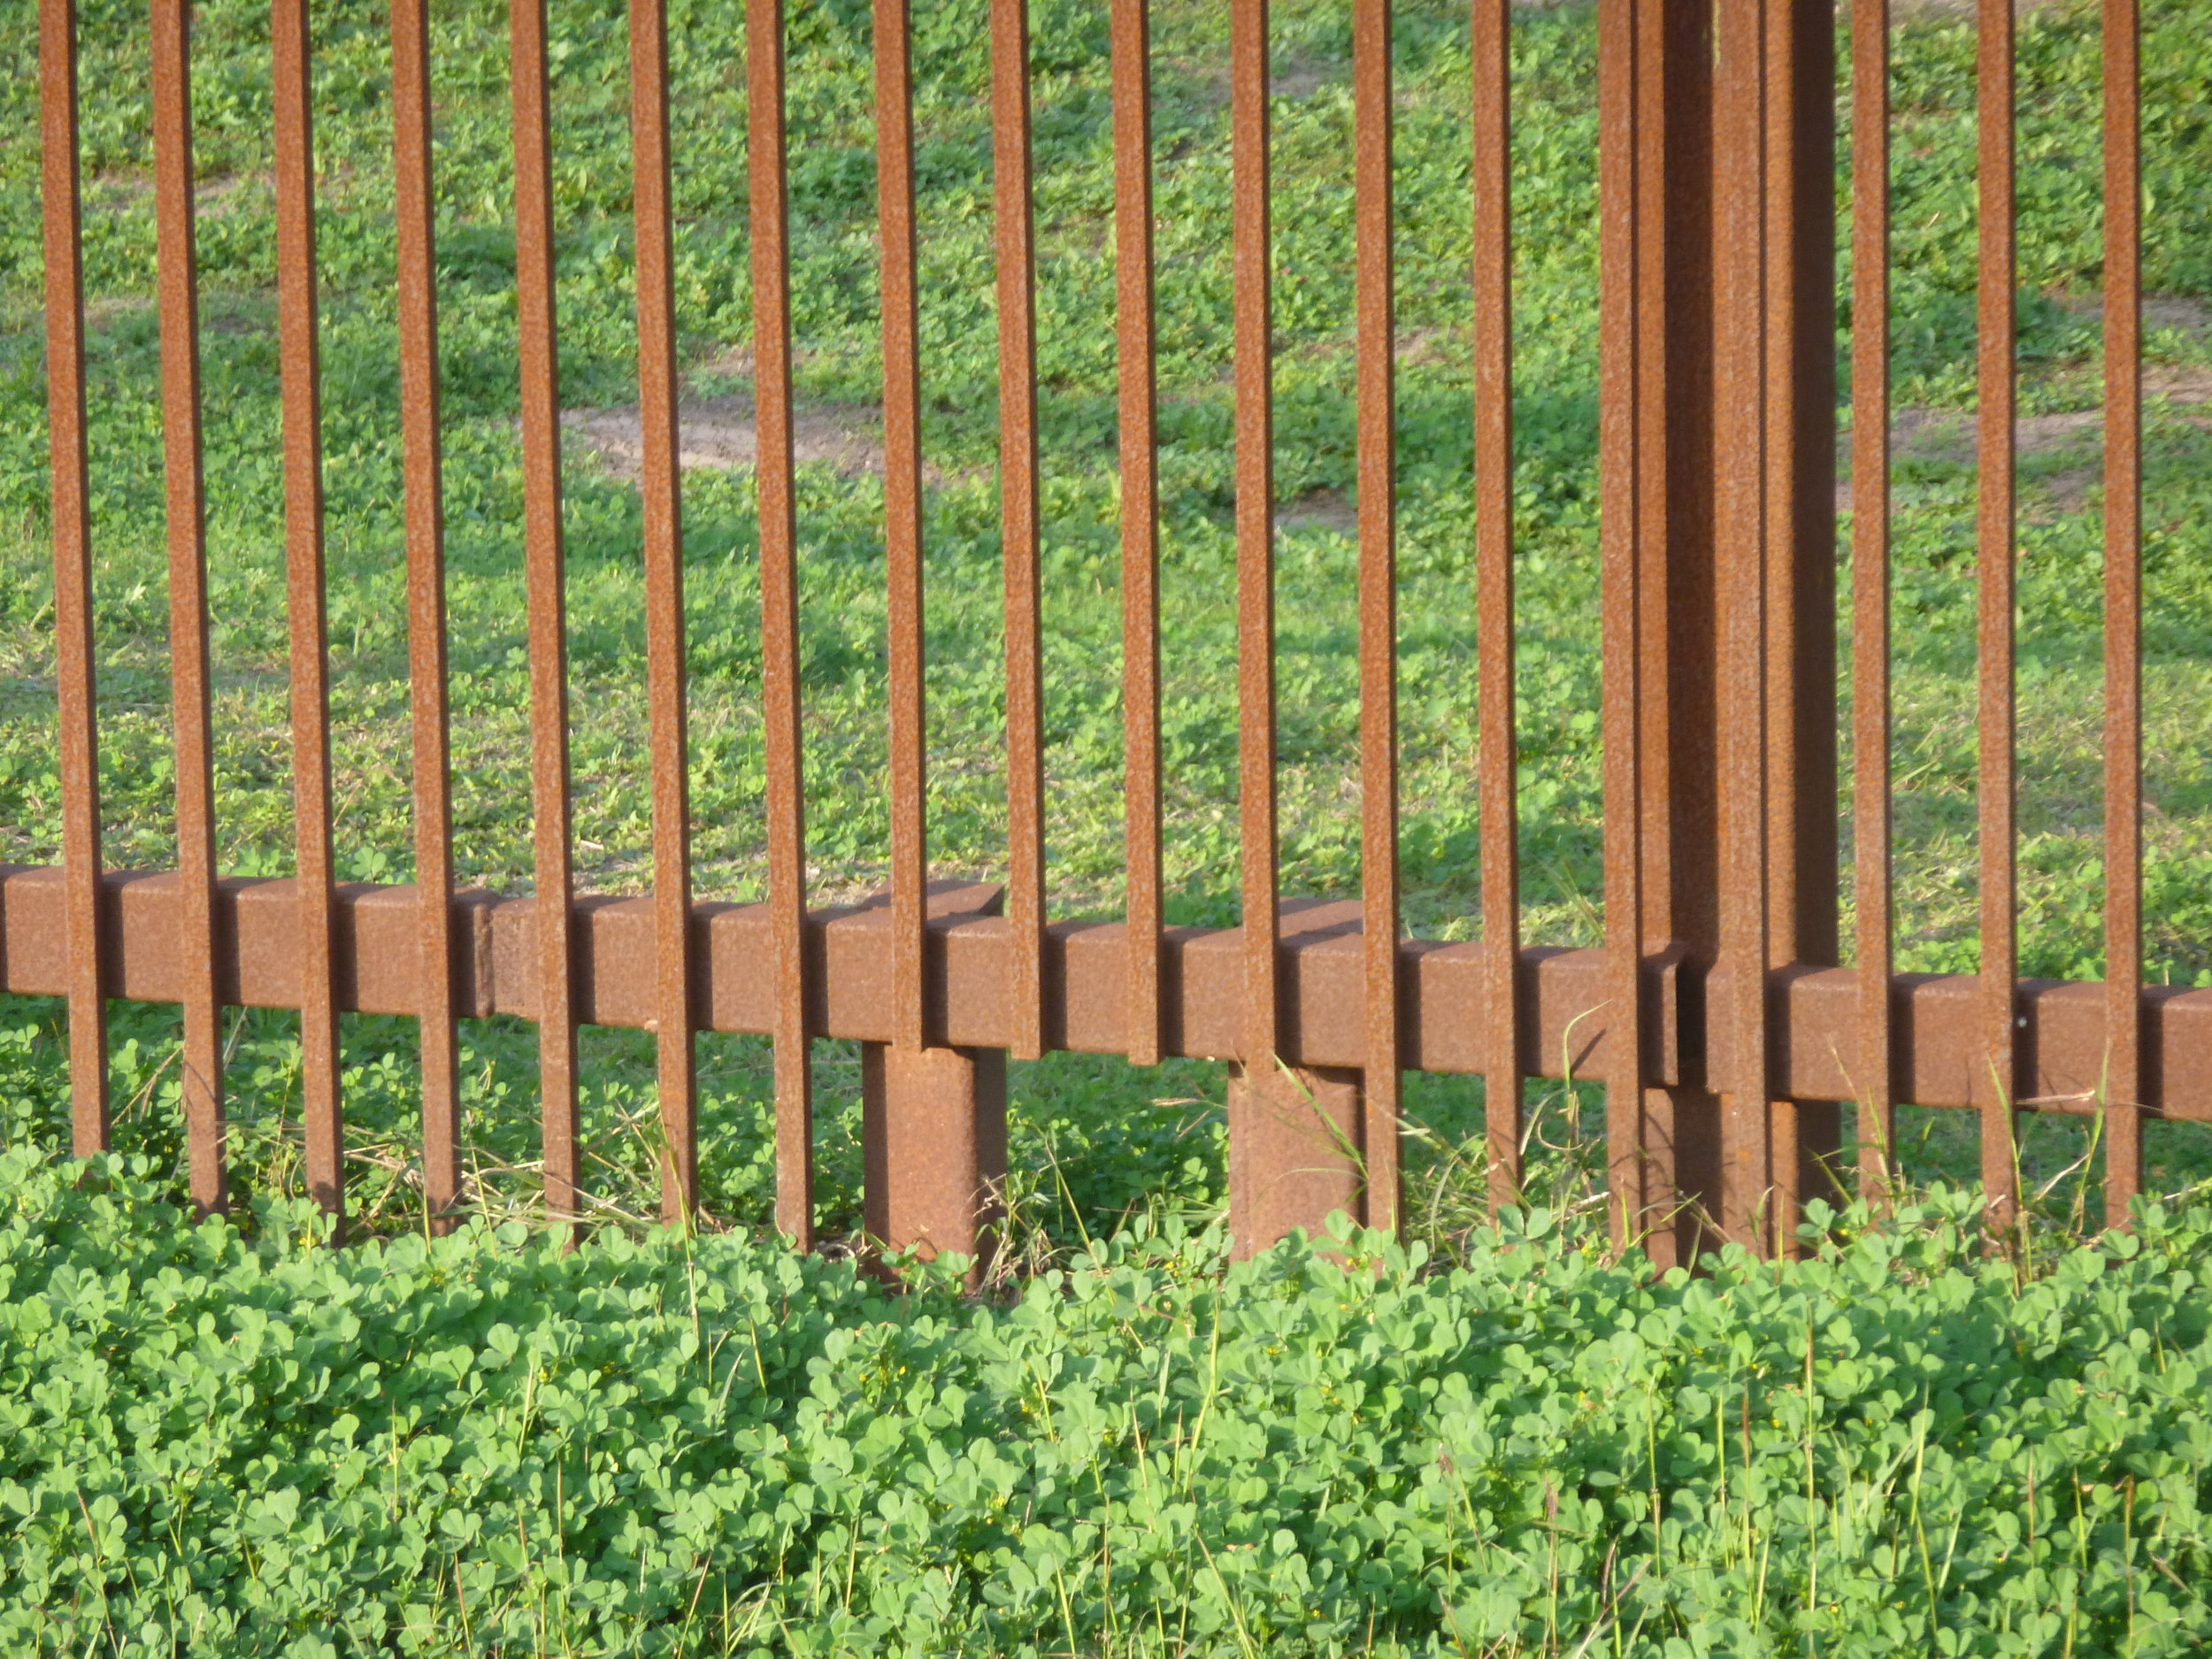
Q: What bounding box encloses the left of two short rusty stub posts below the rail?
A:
[861,1042,1007,1283]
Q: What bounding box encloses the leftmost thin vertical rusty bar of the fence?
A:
[38,0,109,1157]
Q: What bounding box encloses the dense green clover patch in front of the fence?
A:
[0,1150,2212,1659]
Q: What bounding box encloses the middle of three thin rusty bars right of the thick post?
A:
[1976,0,2020,1228]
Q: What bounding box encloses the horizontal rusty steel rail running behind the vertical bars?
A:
[12,865,2212,1122]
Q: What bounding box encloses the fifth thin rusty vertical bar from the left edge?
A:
[507,0,582,1215]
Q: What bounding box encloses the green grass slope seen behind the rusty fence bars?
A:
[0,0,2212,1246]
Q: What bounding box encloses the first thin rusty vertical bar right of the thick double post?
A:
[1852,0,1898,1202]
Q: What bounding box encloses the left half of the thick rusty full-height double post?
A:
[1600,3,1721,1265]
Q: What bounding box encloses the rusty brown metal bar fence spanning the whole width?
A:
[0,0,2212,1263]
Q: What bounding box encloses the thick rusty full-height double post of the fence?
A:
[1601,0,1839,1265]
